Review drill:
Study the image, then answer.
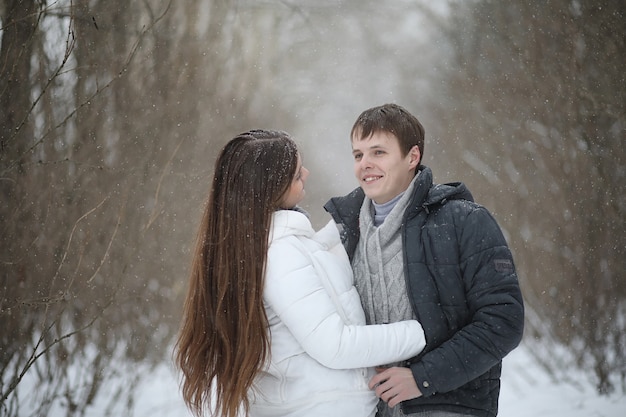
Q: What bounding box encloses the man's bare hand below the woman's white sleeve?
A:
[369,367,422,407]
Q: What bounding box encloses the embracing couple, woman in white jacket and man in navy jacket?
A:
[176,104,524,417]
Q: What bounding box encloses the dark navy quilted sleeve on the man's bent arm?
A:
[411,207,524,396]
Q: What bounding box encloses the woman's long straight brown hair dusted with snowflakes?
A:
[175,130,298,417]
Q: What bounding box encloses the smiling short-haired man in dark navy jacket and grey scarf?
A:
[324,104,524,417]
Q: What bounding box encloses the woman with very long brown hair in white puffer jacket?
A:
[176,130,425,417]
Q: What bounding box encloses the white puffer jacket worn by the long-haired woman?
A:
[250,210,425,417]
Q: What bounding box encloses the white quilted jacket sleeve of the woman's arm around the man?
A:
[264,239,425,369]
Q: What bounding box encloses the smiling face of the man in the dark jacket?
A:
[352,132,420,204]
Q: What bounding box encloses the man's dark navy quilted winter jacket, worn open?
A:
[324,166,524,417]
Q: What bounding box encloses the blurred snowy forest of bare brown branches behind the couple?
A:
[0,0,626,417]
